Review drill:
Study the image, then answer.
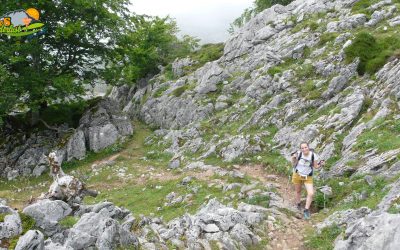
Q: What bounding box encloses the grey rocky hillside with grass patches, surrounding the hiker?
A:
[0,0,400,249]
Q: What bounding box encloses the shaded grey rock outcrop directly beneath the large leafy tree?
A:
[0,98,133,180]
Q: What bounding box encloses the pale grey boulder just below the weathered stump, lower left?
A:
[23,200,72,236]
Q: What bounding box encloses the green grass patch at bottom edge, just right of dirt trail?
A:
[306,225,343,250]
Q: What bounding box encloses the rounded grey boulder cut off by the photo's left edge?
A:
[0,205,22,240]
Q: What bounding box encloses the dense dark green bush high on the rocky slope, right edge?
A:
[344,32,400,75]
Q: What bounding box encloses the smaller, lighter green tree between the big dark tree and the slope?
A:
[107,15,199,84]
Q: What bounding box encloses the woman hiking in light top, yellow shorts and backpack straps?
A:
[291,142,325,220]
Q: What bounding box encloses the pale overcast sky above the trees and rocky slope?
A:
[131,0,253,43]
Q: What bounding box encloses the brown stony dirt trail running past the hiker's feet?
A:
[239,165,312,250]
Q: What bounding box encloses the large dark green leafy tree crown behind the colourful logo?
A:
[0,0,129,120]
